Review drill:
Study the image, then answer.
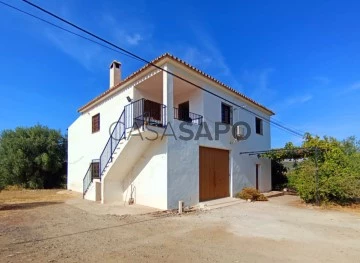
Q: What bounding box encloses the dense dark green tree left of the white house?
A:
[0,125,67,188]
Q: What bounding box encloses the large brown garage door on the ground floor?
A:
[199,147,229,201]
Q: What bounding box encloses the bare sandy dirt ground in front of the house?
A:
[0,190,360,262]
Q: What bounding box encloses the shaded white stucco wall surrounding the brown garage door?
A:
[167,65,271,208]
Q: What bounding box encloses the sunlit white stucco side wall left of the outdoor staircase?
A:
[67,87,133,192]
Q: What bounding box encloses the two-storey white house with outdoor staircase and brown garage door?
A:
[67,53,274,209]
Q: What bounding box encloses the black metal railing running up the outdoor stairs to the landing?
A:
[83,99,166,198]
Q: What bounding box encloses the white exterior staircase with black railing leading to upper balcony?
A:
[83,99,166,203]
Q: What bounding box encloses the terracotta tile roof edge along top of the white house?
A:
[78,53,275,115]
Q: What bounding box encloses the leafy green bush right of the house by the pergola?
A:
[288,136,360,204]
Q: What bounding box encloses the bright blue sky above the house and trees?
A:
[0,0,360,147]
